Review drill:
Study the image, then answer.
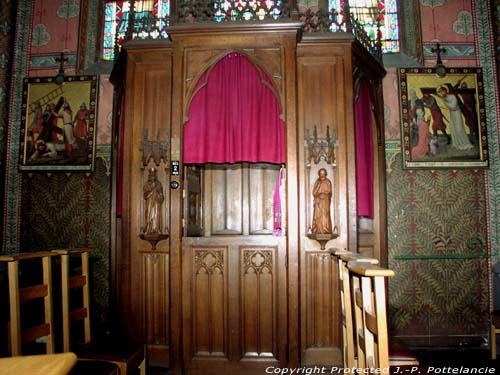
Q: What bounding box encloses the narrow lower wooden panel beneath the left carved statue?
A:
[141,252,169,344]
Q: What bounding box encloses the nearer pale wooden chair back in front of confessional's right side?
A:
[347,262,394,370]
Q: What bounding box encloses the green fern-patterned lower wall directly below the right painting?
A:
[387,154,489,345]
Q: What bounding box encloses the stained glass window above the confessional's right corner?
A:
[328,0,399,53]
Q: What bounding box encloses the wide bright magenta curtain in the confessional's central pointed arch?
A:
[184,52,285,164]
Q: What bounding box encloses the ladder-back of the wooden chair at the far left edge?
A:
[0,252,55,356]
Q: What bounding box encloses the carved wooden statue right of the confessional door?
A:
[311,168,332,234]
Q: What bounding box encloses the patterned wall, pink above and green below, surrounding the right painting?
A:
[384,0,500,345]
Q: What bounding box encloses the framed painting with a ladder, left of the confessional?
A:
[19,76,99,172]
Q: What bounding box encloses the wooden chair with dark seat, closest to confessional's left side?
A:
[53,247,146,375]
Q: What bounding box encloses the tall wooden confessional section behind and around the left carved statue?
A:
[114,47,172,365]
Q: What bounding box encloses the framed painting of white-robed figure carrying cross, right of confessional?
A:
[398,68,488,169]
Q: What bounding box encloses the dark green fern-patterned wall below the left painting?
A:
[20,158,110,322]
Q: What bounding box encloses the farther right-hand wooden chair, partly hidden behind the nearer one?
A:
[330,249,378,369]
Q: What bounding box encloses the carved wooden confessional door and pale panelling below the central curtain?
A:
[182,163,287,374]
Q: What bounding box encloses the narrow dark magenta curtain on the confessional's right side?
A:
[354,80,374,219]
